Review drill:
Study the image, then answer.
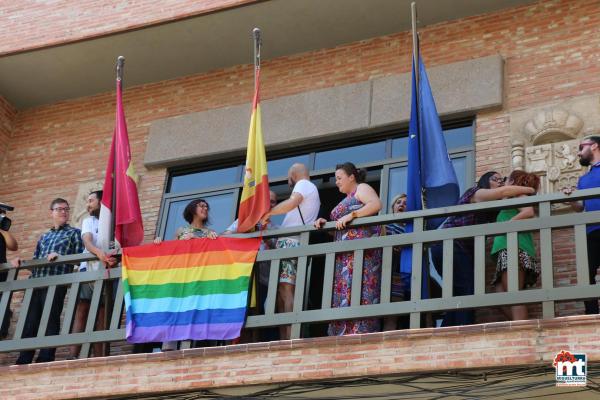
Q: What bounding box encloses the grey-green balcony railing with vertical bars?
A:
[0,189,600,358]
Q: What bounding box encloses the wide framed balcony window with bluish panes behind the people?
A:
[157,121,474,236]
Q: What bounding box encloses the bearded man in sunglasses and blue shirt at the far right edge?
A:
[564,136,600,314]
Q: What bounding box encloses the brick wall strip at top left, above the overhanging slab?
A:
[0,0,257,55]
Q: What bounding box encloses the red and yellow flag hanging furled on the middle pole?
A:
[238,68,270,233]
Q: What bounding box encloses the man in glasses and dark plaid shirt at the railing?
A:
[13,198,84,364]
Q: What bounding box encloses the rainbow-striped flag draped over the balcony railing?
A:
[122,237,260,343]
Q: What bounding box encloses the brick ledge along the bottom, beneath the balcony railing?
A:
[0,315,600,400]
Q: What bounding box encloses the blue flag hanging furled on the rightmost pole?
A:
[400,54,460,298]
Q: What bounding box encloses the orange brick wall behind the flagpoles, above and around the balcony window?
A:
[0,0,600,360]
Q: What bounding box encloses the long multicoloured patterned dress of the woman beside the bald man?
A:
[327,192,381,336]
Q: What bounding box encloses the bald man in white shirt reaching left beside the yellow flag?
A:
[263,163,321,339]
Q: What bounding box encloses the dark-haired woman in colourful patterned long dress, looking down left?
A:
[315,162,381,336]
